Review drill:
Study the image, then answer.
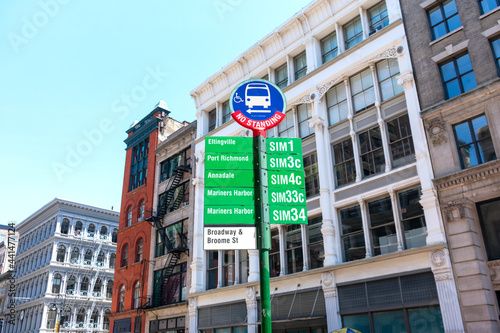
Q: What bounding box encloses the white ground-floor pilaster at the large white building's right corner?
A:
[429,248,464,333]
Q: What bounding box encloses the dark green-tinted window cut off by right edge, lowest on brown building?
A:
[477,198,500,261]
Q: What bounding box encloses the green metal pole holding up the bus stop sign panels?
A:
[253,131,272,333]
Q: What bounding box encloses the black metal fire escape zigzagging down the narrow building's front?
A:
[145,165,191,309]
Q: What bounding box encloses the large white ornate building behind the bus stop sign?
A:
[188,0,464,333]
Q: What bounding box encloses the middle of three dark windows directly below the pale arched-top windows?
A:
[359,126,385,177]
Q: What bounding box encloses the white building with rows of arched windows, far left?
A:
[4,198,119,333]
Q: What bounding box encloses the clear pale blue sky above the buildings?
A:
[0,0,310,224]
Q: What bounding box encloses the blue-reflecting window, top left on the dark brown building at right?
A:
[427,0,462,40]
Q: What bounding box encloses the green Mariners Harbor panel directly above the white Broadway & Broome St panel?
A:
[205,206,255,225]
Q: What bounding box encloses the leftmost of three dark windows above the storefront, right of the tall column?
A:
[340,205,366,262]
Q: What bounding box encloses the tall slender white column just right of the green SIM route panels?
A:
[309,115,338,266]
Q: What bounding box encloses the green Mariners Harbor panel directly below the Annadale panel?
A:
[205,188,254,207]
